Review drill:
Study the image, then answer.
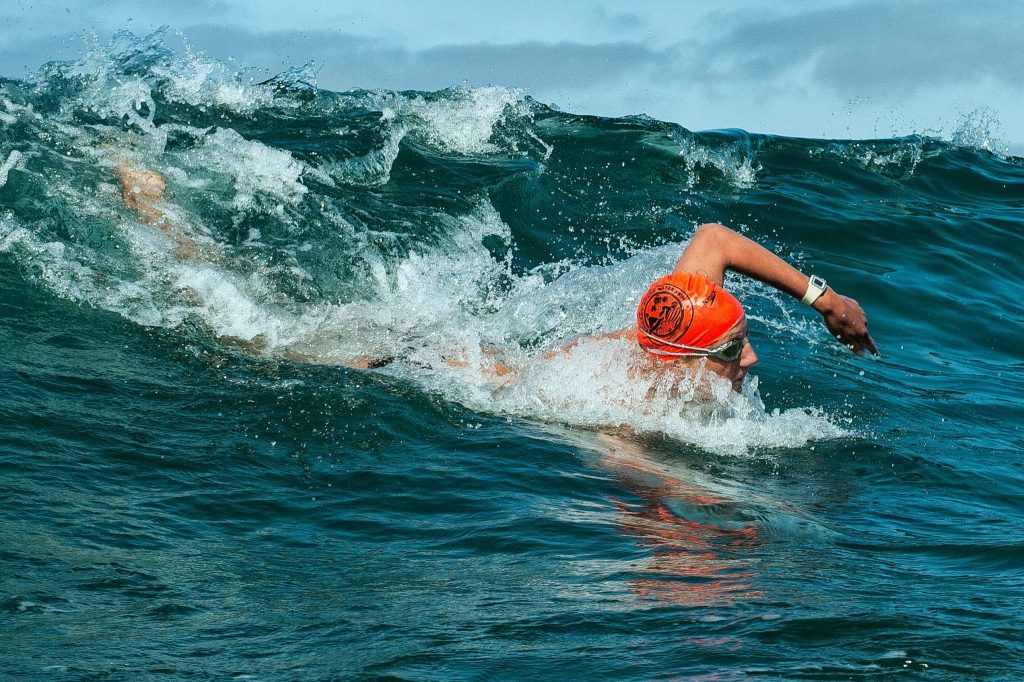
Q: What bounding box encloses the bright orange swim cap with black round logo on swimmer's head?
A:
[637,272,743,360]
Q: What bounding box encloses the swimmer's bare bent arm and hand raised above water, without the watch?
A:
[674,223,879,355]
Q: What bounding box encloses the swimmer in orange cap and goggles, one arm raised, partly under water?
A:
[115,162,878,392]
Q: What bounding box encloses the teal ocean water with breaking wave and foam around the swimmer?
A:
[0,33,1024,680]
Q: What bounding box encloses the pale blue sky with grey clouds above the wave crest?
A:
[0,0,1024,154]
